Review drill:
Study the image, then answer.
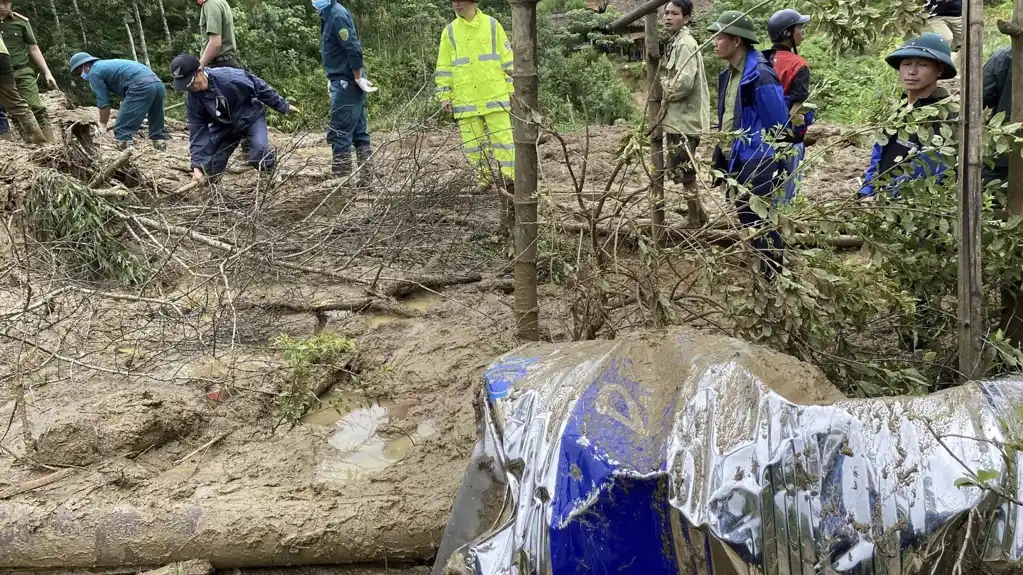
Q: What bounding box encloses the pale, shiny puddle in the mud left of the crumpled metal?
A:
[302,398,437,485]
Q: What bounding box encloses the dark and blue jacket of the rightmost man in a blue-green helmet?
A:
[859,88,957,196]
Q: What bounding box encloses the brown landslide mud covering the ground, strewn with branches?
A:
[0,97,869,568]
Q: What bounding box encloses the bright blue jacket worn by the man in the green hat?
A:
[715,49,789,193]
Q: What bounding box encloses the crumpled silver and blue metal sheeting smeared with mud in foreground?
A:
[434,331,1023,575]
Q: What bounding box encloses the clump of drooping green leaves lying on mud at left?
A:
[25,173,149,284]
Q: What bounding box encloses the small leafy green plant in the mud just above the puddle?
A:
[274,334,356,425]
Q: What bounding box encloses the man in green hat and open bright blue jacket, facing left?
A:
[707,10,789,280]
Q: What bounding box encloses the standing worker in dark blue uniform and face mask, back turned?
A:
[313,0,376,183]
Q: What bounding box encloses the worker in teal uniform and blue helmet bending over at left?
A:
[70,52,169,150]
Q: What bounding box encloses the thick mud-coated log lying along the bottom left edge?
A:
[0,495,435,569]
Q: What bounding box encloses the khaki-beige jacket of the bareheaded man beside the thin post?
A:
[661,28,710,136]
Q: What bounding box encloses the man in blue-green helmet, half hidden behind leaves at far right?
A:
[859,33,957,197]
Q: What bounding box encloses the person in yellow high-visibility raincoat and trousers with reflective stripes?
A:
[434,0,515,188]
